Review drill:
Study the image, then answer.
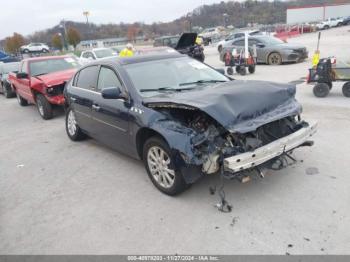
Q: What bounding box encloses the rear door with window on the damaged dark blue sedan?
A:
[69,65,99,132]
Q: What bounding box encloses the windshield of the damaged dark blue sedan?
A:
[125,57,229,96]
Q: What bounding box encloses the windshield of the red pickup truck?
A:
[29,57,79,76]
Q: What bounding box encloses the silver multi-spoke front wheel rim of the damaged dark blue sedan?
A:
[147,146,175,188]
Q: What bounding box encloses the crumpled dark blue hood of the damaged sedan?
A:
[143,80,301,133]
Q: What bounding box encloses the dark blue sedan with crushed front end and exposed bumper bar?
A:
[65,52,316,195]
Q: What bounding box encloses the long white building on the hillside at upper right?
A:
[287,4,350,24]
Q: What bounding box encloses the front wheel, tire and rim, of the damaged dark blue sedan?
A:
[143,137,189,196]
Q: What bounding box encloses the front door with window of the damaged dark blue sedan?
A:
[92,66,130,152]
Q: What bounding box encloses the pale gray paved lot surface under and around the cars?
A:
[0,24,350,254]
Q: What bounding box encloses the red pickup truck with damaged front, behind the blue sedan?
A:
[9,56,80,119]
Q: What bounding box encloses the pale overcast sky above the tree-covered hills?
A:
[0,0,230,39]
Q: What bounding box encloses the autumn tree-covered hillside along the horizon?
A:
[0,0,350,52]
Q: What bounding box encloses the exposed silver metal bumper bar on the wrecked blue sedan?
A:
[224,123,317,173]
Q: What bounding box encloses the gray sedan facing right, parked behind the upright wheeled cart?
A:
[220,35,308,65]
